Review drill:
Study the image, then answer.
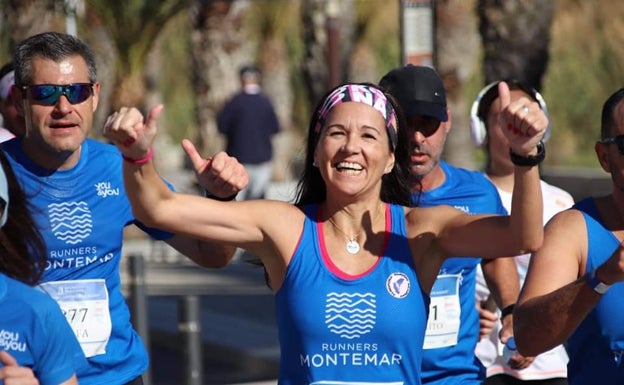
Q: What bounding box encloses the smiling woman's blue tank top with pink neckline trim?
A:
[275,205,428,385]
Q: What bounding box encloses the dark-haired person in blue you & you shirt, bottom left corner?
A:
[0,151,86,385]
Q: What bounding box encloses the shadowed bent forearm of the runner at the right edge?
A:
[514,278,600,356]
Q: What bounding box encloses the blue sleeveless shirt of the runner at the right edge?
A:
[565,198,624,385]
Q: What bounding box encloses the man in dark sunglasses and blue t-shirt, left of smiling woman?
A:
[3,32,248,385]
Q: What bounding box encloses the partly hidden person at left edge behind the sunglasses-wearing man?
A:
[0,62,25,142]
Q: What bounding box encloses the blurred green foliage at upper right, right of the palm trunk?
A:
[543,0,624,167]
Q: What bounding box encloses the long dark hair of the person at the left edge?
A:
[0,150,47,285]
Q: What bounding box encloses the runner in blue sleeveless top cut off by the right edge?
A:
[514,88,624,385]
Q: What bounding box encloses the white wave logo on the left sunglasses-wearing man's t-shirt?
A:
[48,201,93,245]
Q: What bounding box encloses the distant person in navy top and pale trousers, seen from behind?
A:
[217,66,280,200]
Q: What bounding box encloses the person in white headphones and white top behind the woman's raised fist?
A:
[470,80,574,385]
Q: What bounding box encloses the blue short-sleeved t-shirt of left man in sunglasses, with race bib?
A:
[2,138,169,385]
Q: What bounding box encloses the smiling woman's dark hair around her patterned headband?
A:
[295,83,411,206]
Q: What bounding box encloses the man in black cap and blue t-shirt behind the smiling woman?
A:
[379,64,519,385]
